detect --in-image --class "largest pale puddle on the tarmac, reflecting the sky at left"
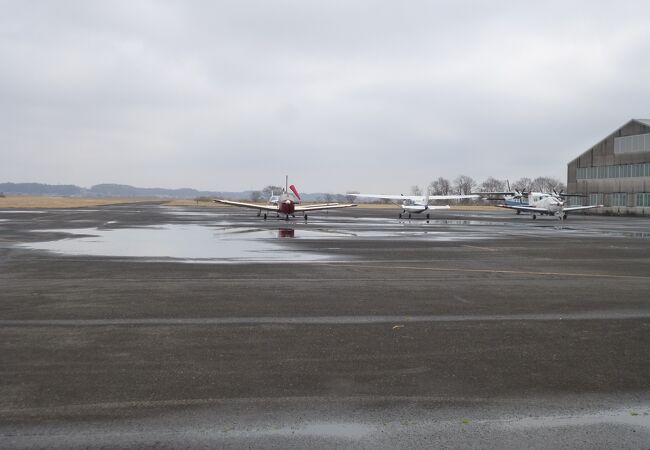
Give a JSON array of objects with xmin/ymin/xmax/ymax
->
[{"xmin": 18, "ymin": 225, "xmax": 330, "ymax": 263}]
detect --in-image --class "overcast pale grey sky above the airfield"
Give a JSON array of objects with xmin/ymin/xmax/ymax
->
[{"xmin": 0, "ymin": 0, "xmax": 650, "ymax": 192}]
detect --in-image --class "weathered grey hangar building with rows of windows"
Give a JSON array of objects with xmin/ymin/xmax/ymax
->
[{"xmin": 567, "ymin": 119, "xmax": 650, "ymax": 215}]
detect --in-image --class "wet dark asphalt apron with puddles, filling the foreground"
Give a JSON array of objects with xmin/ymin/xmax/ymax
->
[{"xmin": 0, "ymin": 204, "xmax": 650, "ymax": 449}]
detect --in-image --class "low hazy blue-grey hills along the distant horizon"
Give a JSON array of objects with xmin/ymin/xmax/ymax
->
[{"xmin": 0, "ymin": 183, "xmax": 334, "ymax": 201}]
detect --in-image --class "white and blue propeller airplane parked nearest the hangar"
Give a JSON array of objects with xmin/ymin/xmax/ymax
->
[{"xmin": 474, "ymin": 191, "xmax": 603, "ymax": 220}]
